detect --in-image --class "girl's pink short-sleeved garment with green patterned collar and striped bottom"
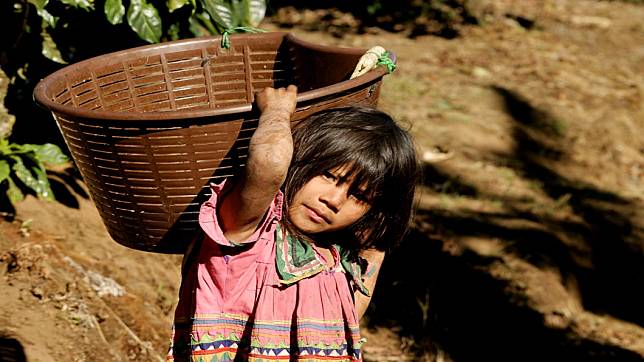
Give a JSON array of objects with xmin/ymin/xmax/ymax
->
[{"xmin": 168, "ymin": 181, "xmax": 363, "ymax": 361}]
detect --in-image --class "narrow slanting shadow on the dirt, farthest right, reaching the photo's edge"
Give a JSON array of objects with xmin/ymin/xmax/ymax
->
[{"xmin": 495, "ymin": 87, "xmax": 644, "ymax": 325}]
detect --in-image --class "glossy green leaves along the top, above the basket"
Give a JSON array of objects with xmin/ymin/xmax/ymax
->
[{"xmin": 8, "ymin": 0, "xmax": 266, "ymax": 64}]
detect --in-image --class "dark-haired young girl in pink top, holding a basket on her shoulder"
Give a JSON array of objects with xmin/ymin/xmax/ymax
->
[{"xmin": 168, "ymin": 86, "xmax": 418, "ymax": 362}]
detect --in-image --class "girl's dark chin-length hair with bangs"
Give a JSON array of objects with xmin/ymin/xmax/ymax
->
[{"xmin": 284, "ymin": 106, "xmax": 420, "ymax": 250}]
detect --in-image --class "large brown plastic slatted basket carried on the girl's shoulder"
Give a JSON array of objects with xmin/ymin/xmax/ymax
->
[{"xmin": 34, "ymin": 33, "xmax": 394, "ymax": 253}]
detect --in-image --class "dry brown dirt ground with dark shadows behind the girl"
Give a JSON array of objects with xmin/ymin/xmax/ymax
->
[{"xmin": 0, "ymin": 0, "xmax": 644, "ymax": 362}]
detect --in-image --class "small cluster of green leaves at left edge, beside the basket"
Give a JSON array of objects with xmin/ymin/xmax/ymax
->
[{"xmin": 0, "ymin": 138, "xmax": 68, "ymax": 203}]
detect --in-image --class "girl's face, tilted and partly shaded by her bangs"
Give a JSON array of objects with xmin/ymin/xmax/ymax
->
[{"xmin": 288, "ymin": 166, "xmax": 371, "ymax": 234}]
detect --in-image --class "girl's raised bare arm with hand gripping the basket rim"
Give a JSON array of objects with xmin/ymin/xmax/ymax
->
[{"xmin": 218, "ymin": 85, "xmax": 297, "ymax": 242}]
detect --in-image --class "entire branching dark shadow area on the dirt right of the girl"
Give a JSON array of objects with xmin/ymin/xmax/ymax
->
[{"xmin": 367, "ymin": 88, "xmax": 644, "ymax": 361}]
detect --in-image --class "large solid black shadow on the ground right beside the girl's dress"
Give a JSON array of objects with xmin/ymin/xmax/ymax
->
[{"xmin": 368, "ymin": 226, "xmax": 641, "ymax": 362}]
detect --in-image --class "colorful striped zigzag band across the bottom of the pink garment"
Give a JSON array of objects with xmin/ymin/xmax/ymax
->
[{"xmin": 168, "ymin": 313, "xmax": 364, "ymax": 361}]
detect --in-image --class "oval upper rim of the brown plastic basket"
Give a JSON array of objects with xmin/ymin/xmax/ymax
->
[{"xmin": 33, "ymin": 32, "xmax": 396, "ymax": 121}]
